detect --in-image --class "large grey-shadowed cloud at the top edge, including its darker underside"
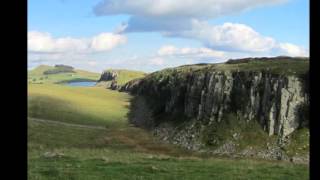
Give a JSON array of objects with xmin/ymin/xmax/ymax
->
[{"xmin": 93, "ymin": 0, "xmax": 287, "ymax": 32}]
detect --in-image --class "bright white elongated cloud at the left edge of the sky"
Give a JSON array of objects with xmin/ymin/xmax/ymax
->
[{"xmin": 28, "ymin": 31, "xmax": 127, "ymax": 53}]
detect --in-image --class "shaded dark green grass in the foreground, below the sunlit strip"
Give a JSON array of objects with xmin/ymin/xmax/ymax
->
[{"xmin": 28, "ymin": 121, "xmax": 308, "ymax": 180}]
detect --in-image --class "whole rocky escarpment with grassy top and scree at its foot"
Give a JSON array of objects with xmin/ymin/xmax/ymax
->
[{"xmin": 120, "ymin": 57, "xmax": 309, "ymax": 162}]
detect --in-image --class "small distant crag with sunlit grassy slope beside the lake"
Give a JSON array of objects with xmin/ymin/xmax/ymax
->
[{"xmin": 97, "ymin": 69, "xmax": 146, "ymax": 89}]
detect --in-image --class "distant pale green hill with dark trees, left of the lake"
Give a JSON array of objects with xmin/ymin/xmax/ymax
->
[{"xmin": 28, "ymin": 65, "xmax": 99, "ymax": 84}]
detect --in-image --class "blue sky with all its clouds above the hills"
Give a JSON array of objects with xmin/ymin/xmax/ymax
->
[{"xmin": 28, "ymin": 0, "xmax": 309, "ymax": 72}]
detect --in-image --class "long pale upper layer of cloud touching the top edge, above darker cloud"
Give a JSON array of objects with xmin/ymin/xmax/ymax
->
[{"xmin": 94, "ymin": 0, "xmax": 286, "ymax": 18}]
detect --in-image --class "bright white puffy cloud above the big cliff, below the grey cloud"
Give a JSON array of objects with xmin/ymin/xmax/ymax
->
[{"xmin": 165, "ymin": 20, "xmax": 276, "ymax": 52}]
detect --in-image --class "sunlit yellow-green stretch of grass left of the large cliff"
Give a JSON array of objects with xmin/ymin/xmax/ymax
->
[{"xmin": 28, "ymin": 84, "xmax": 130, "ymax": 126}]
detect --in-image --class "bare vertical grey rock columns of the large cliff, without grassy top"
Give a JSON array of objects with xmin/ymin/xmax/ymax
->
[{"xmin": 124, "ymin": 72, "xmax": 308, "ymax": 137}]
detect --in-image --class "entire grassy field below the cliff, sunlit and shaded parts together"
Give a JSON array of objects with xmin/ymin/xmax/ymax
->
[{"xmin": 28, "ymin": 68, "xmax": 309, "ymax": 180}]
